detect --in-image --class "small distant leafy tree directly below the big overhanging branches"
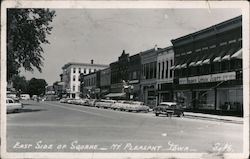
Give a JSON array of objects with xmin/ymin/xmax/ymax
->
[{"xmin": 12, "ymin": 75, "xmax": 28, "ymax": 93}]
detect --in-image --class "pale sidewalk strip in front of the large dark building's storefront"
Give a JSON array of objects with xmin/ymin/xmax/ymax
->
[{"xmin": 184, "ymin": 112, "xmax": 243, "ymax": 124}]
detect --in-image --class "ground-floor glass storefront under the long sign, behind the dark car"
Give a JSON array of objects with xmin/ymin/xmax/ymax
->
[{"xmin": 174, "ymin": 75, "xmax": 243, "ymax": 116}]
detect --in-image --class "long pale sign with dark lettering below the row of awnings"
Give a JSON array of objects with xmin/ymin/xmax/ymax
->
[{"xmin": 179, "ymin": 72, "xmax": 236, "ymax": 84}]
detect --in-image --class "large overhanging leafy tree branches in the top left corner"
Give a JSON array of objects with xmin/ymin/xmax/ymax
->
[{"xmin": 7, "ymin": 9, "xmax": 55, "ymax": 80}]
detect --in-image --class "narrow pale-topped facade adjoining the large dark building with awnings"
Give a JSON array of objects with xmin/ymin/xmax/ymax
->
[{"xmin": 156, "ymin": 46, "xmax": 174, "ymax": 103}]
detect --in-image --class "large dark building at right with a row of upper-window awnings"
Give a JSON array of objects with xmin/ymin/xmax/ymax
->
[{"xmin": 172, "ymin": 16, "xmax": 243, "ymax": 115}]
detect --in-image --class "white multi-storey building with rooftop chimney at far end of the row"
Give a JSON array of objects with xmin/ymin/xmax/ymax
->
[{"xmin": 62, "ymin": 60, "xmax": 109, "ymax": 99}]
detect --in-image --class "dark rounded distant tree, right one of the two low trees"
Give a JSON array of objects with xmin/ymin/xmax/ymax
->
[{"xmin": 28, "ymin": 78, "xmax": 47, "ymax": 97}]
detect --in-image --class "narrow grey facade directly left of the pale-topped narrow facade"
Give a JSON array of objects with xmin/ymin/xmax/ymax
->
[{"xmin": 140, "ymin": 46, "xmax": 159, "ymax": 107}]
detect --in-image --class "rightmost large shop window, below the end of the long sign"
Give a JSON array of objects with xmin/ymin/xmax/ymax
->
[{"xmin": 217, "ymin": 88, "xmax": 243, "ymax": 112}]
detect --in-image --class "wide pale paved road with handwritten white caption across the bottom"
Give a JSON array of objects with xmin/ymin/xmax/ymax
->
[{"xmin": 7, "ymin": 101, "xmax": 243, "ymax": 152}]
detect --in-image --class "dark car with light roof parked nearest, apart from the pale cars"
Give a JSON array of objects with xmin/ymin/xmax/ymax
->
[{"xmin": 153, "ymin": 102, "xmax": 184, "ymax": 117}]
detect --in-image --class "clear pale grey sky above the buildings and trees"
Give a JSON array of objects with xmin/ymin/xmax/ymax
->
[{"xmin": 21, "ymin": 8, "xmax": 241, "ymax": 85}]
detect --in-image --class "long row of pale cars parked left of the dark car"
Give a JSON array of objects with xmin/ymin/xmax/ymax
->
[{"xmin": 60, "ymin": 99, "xmax": 149, "ymax": 112}]
